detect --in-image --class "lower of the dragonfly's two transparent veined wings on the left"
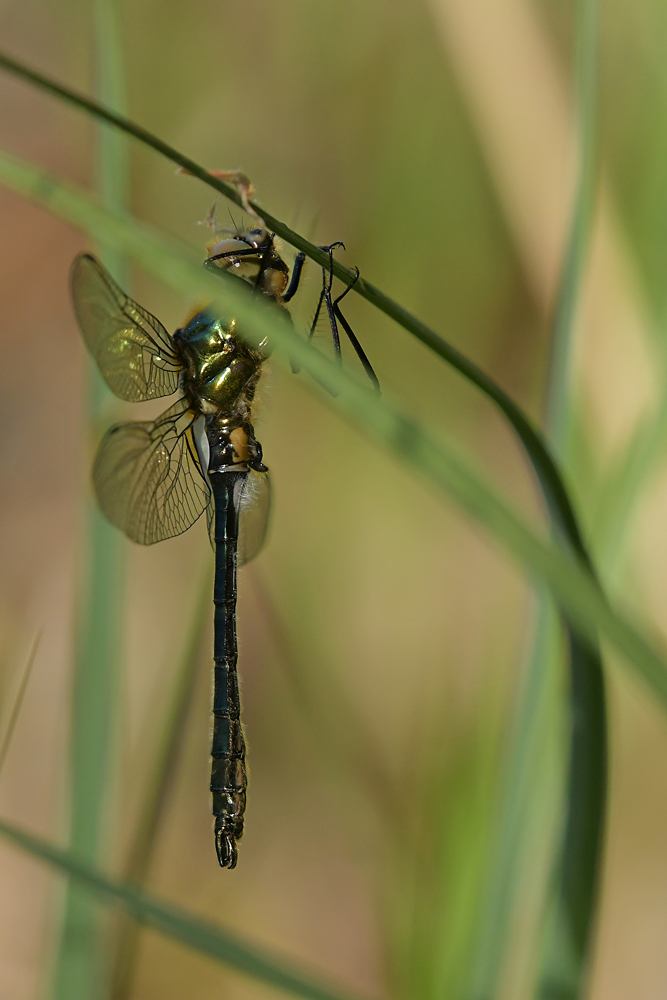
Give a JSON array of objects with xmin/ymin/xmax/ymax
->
[{"xmin": 93, "ymin": 399, "xmax": 210, "ymax": 545}]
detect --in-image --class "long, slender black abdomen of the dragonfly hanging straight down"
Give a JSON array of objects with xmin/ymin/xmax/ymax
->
[{"xmin": 209, "ymin": 471, "xmax": 248, "ymax": 868}]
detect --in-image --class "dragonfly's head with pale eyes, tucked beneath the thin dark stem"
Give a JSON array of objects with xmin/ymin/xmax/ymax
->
[{"xmin": 206, "ymin": 229, "xmax": 289, "ymax": 299}]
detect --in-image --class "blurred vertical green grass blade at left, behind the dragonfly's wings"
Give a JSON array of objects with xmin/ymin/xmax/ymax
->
[{"xmin": 52, "ymin": 0, "xmax": 128, "ymax": 1000}]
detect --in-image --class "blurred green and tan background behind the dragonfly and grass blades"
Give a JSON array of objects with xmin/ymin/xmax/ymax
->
[{"xmin": 0, "ymin": 0, "xmax": 667, "ymax": 1000}]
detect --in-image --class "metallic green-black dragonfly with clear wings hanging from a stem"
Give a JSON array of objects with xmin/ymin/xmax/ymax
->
[{"xmin": 70, "ymin": 226, "xmax": 378, "ymax": 869}]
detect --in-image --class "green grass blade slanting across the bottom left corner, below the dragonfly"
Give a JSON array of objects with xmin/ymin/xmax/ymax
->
[{"xmin": 0, "ymin": 821, "xmax": 366, "ymax": 1000}]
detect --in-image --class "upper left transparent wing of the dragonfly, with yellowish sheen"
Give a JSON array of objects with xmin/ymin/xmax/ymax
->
[{"xmin": 70, "ymin": 253, "xmax": 181, "ymax": 403}]
